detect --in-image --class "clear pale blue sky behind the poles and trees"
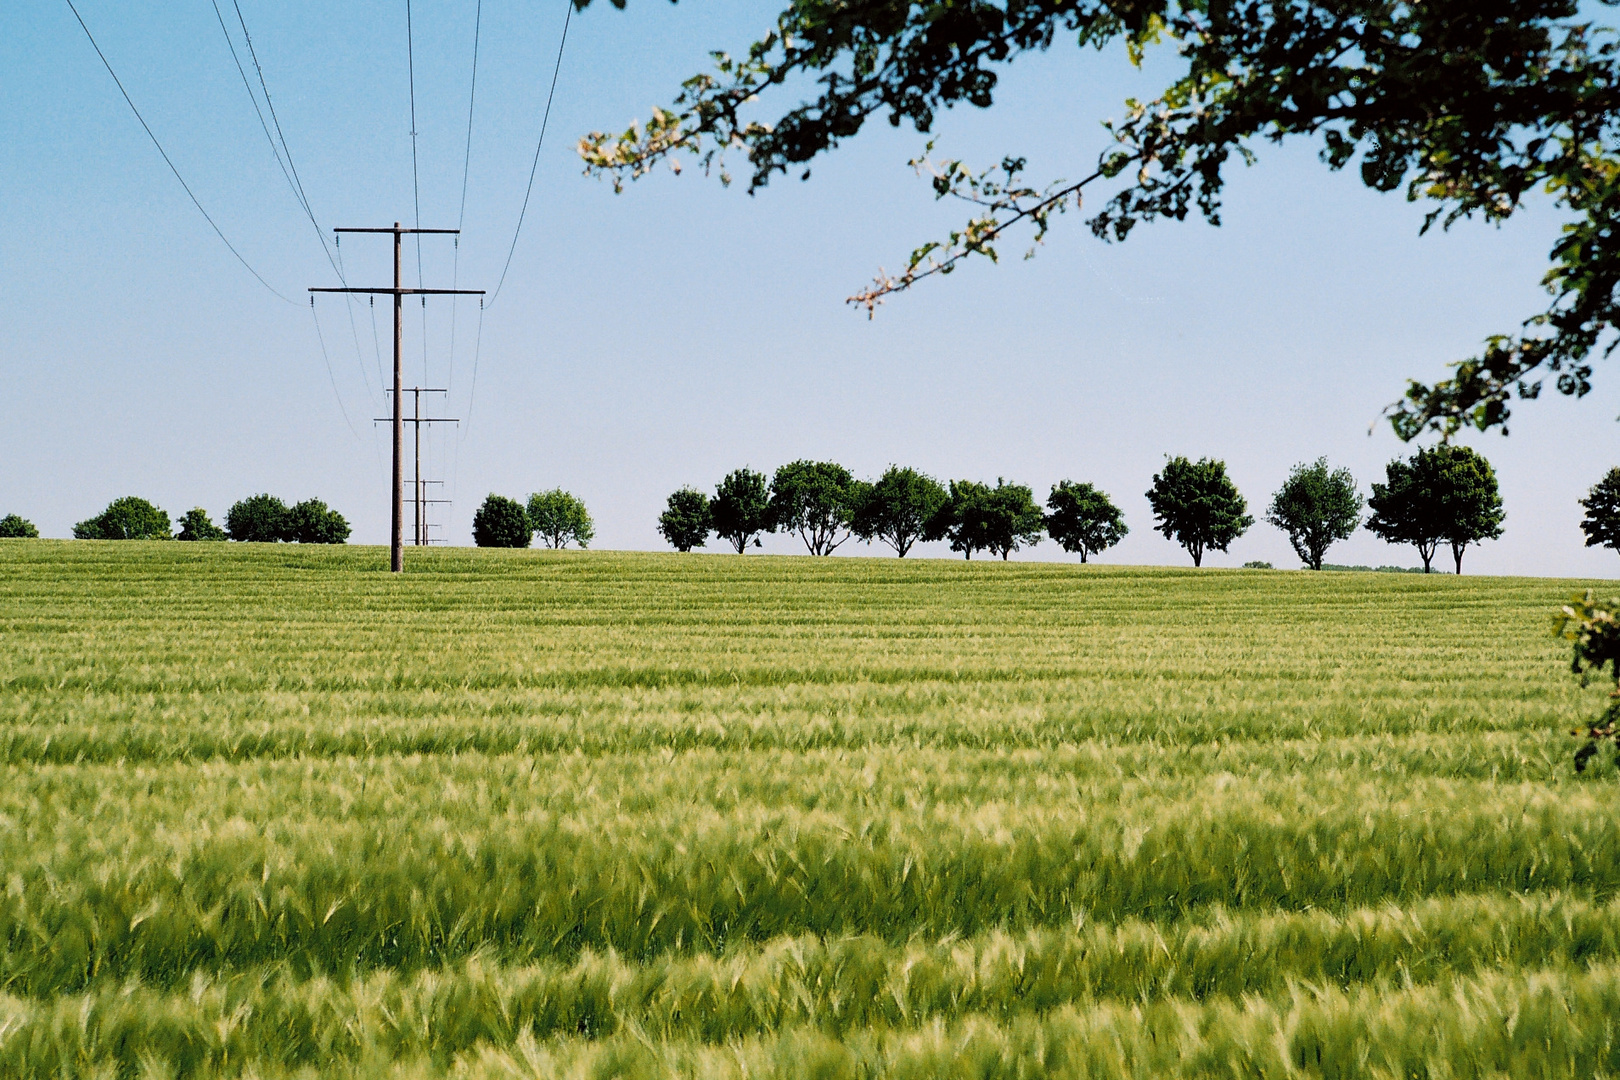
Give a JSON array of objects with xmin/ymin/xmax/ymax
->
[{"xmin": 0, "ymin": 0, "xmax": 1620, "ymax": 578}]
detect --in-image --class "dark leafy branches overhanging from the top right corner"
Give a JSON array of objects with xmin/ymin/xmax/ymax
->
[{"xmin": 577, "ymin": 0, "xmax": 1620, "ymax": 439}]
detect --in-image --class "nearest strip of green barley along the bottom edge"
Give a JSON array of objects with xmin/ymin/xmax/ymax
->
[{"xmin": 9, "ymin": 938, "xmax": 1620, "ymax": 1080}]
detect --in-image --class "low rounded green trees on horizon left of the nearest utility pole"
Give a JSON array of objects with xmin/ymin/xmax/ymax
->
[{"xmin": 51, "ymin": 495, "xmax": 348, "ymax": 544}]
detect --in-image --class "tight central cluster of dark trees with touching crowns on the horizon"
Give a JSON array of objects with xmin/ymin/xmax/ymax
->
[{"xmin": 658, "ymin": 460, "xmax": 1129, "ymax": 562}]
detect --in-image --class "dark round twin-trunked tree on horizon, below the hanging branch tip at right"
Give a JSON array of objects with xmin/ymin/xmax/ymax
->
[{"xmin": 1367, "ymin": 444, "xmax": 1505, "ymax": 573}]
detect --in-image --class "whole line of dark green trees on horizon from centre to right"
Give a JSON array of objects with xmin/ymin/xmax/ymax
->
[{"xmin": 658, "ymin": 444, "xmax": 1516, "ymax": 573}]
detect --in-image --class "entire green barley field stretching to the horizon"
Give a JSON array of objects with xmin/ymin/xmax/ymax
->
[{"xmin": 0, "ymin": 541, "xmax": 1620, "ymax": 1080}]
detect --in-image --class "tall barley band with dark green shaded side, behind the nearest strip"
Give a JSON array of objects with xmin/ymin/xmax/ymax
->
[{"xmin": 9, "ymin": 777, "xmax": 1620, "ymax": 994}]
